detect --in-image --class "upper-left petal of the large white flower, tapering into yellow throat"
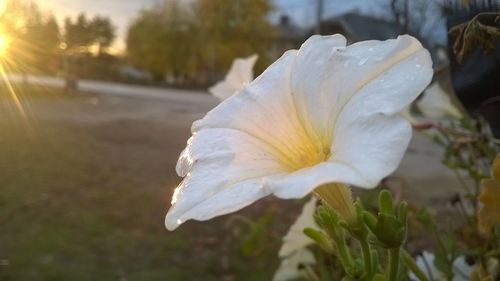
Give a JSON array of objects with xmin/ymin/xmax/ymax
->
[{"xmin": 192, "ymin": 50, "xmax": 315, "ymax": 171}]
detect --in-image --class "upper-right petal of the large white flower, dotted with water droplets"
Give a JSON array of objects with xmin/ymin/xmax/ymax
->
[{"xmin": 292, "ymin": 35, "xmax": 433, "ymax": 143}]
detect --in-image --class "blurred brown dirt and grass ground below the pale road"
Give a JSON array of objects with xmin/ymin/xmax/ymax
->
[{"xmin": 0, "ymin": 84, "xmax": 462, "ymax": 280}]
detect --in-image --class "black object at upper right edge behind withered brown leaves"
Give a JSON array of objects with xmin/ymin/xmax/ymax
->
[{"xmin": 448, "ymin": 7, "xmax": 500, "ymax": 137}]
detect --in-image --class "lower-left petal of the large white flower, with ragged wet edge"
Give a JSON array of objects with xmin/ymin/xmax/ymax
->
[{"xmin": 165, "ymin": 129, "xmax": 282, "ymax": 230}]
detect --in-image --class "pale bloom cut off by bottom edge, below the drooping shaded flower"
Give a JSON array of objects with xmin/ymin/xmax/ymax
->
[{"xmin": 273, "ymin": 249, "xmax": 316, "ymax": 281}]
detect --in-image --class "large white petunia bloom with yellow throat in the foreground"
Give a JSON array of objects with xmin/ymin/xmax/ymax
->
[{"xmin": 165, "ymin": 34, "xmax": 433, "ymax": 230}]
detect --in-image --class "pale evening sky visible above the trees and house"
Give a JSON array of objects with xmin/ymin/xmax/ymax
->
[{"xmin": 32, "ymin": 0, "xmax": 446, "ymax": 52}]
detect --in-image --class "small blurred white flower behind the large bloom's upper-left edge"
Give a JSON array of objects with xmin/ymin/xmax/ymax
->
[{"xmin": 208, "ymin": 55, "xmax": 258, "ymax": 100}]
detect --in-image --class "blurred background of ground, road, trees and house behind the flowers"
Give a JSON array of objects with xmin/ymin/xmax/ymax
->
[{"xmin": 0, "ymin": 0, "xmax": 500, "ymax": 281}]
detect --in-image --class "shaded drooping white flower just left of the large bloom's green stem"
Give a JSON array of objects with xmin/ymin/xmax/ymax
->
[{"xmin": 279, "ymin": 197, "xmax": 319, "ymax": 258}]
